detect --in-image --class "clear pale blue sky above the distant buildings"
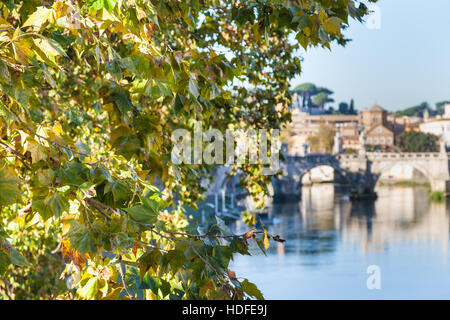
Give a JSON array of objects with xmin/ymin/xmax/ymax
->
[{"xmin": 292, "ymin": 0, "xmax": 450, "ymax": 111}]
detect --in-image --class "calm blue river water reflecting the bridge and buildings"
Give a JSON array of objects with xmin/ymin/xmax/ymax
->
[{"xmin": 230, "ymin": 184, "xmax": 450, "ymax": 299}]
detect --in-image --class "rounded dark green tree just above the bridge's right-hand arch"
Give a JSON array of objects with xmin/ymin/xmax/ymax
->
[{"xmin": 397, "ymin": 131, "xmax": 439, "ymax": 152}]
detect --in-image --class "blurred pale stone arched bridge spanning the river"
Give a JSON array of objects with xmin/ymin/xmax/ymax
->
[{"xmin": 272, "ymin": 152, "xmax": 450, "ymax": 201}]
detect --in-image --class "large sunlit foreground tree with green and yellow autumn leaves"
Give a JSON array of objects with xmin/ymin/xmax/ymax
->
[{"xmin": 0, "ymin": 0, "xmax": 374, "ymax": 299}]
